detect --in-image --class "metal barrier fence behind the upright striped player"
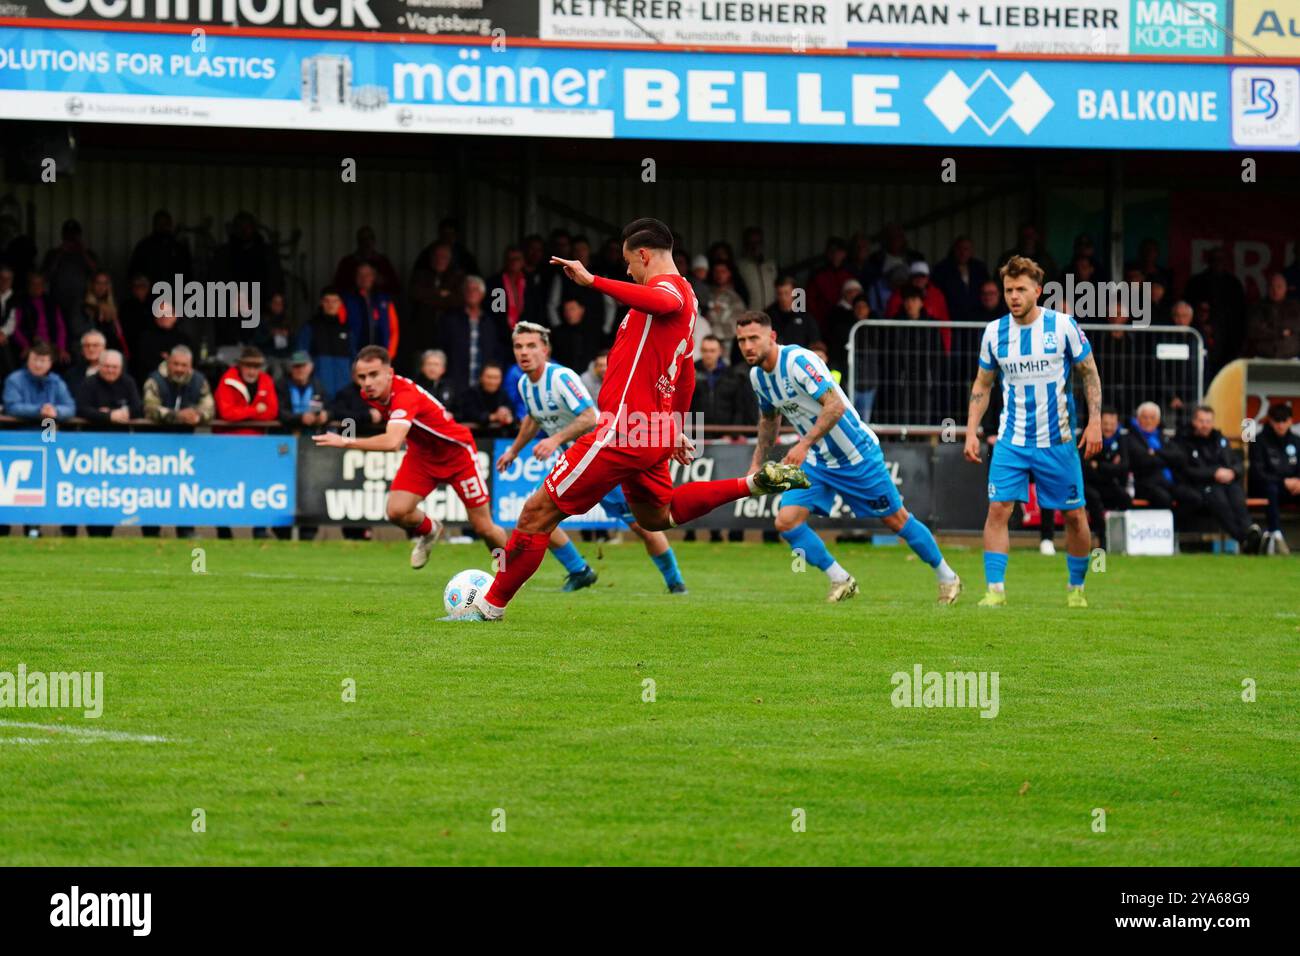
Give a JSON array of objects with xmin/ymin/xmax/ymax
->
[{"xmin": 845, "ymin": 319, "xmax": 1205, "ymax": 433}]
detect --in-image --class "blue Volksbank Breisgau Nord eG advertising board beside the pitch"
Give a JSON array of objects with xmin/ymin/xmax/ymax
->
[{"xmin": 0, "ymin": 432, "xmax": 296, "ymax": 527}]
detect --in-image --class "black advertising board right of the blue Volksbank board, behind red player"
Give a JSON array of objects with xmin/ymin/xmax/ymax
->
[{"xmin": 298, "ymin": 437, "xmax": 491, "ymax": 524}]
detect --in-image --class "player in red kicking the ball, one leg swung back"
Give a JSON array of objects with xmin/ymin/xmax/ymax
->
[{"xmin": 443, "ymin": 219, "xmax": 809, "ymax": 622}]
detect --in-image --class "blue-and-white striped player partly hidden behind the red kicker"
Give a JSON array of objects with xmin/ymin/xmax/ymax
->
[{"xmin": 497, "ymin": 323, "xmax": 686, "ymax": 594}]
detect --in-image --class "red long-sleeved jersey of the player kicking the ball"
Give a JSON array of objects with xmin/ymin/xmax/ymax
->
[{"xmin": 594, "ymin": 274, "xmax": 699, "ymax": 415}]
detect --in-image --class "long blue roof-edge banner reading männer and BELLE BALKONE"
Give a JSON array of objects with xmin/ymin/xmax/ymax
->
[{"xmin": 0, "ymin": 29, "xmax": 1279, "ymax": 150}]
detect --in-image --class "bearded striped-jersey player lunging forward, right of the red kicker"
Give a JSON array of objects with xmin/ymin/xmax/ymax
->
[{"xmin": 736, "ymin": 312, "xmax": 962, "ymax": 605}]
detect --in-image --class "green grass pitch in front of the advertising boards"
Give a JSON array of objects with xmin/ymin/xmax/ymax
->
[{"xmin": 0, "ymin": 538, "xmax": 1300, "ymax": 865}]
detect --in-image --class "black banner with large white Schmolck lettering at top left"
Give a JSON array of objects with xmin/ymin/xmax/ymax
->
[{"xmin": 0, "ymin": 0, "xmax": 538, "ymax": 36}]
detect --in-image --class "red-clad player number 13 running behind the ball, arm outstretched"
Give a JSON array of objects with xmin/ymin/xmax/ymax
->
[{"xmin": 312, "ymin": 345, "xmax": 506, "ymax": 568}]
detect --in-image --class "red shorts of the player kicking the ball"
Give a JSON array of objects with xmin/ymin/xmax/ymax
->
[{"xmin": 545, "ymin": 432, "xmax": 672, "ymax": 515}]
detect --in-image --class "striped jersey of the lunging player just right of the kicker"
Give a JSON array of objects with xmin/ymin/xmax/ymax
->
[{"xmin": 749, "ymin": 345, "xmax": 880, "ymax": 468}]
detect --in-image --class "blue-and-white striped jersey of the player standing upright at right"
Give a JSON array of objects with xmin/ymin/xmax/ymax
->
[{"xmin": 979, "ymin": 308, "xmax": 1092, "ymax": 449}]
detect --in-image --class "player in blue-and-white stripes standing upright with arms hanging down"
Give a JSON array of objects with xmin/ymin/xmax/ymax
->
[{"xmin": 966, "ymin": 256, "xmax": 1101, "ymax": 607}]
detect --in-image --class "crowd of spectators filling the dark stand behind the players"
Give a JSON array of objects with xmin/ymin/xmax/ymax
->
[{"xmin": 0, "ymin": 211, "xmax": 1300, "ymax": 545}]
